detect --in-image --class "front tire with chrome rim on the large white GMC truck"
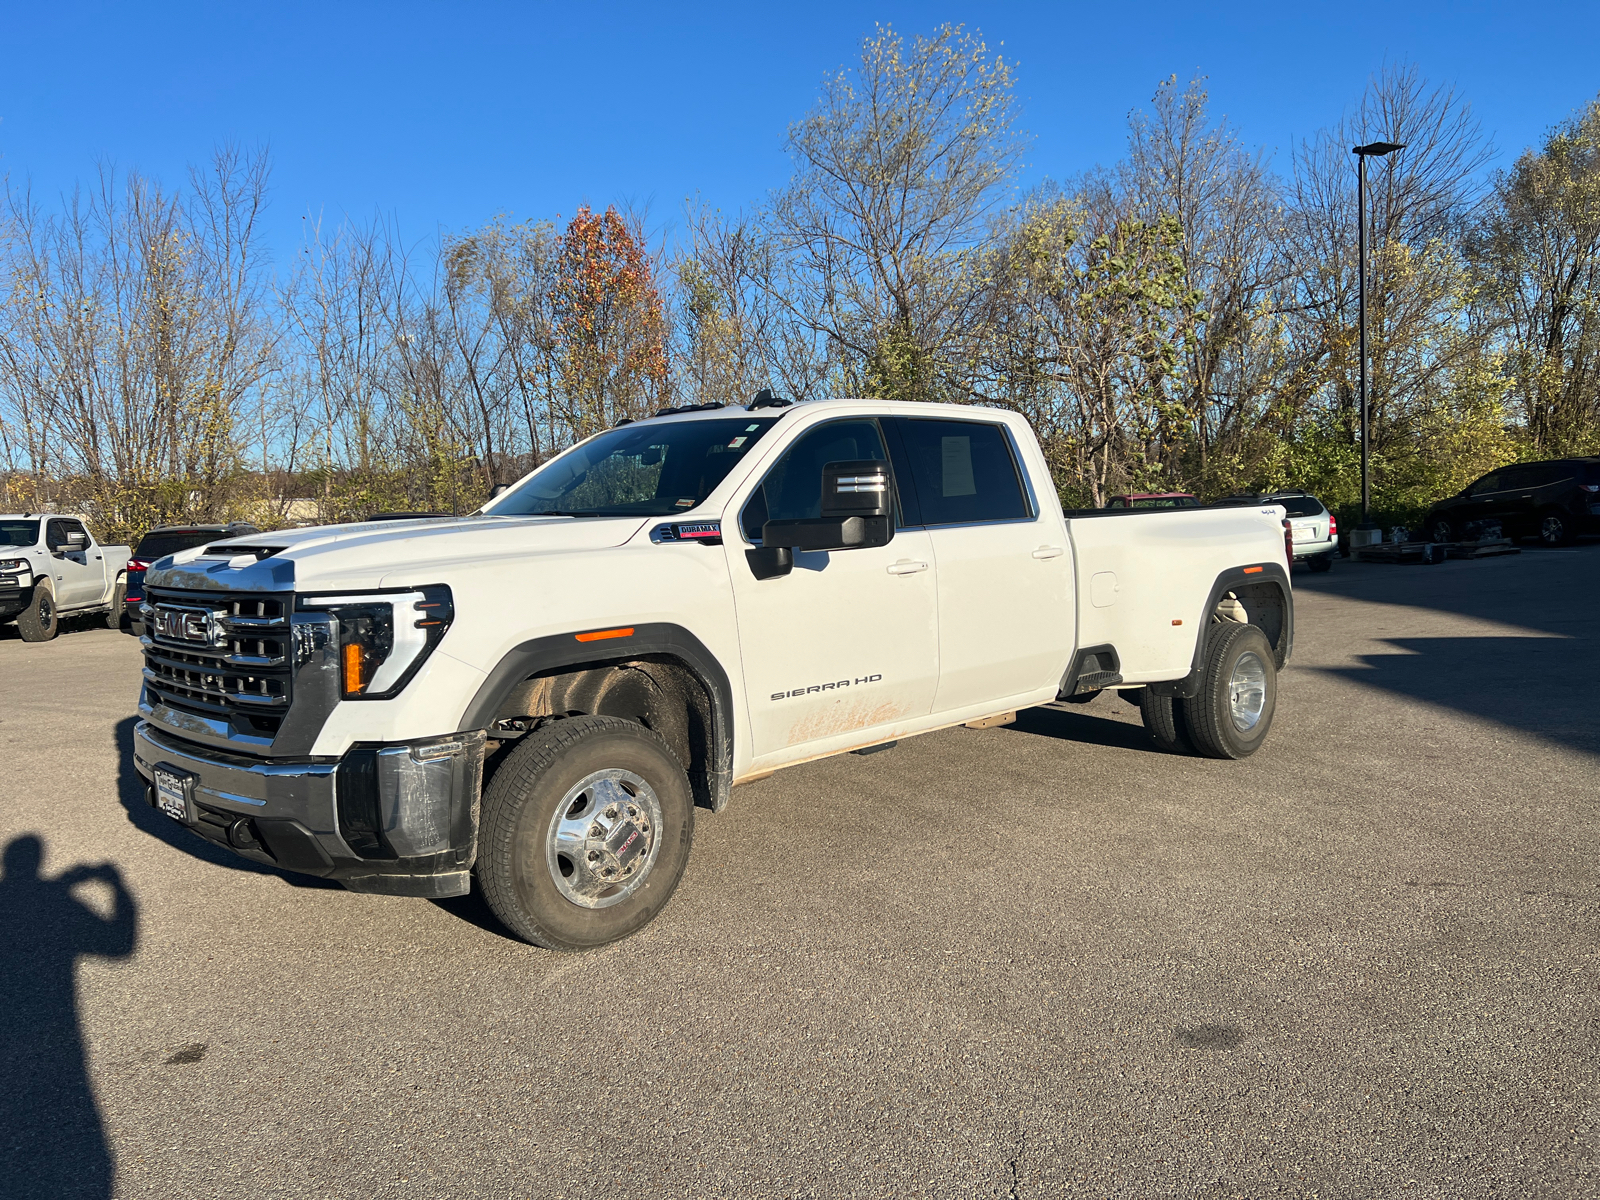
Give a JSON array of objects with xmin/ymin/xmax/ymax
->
[{"xmin": 477, "ymin": 717, "xmax": 694, "ymax": 950}]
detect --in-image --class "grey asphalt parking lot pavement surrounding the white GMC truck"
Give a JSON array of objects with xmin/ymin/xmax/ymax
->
[{"xmin": 0, "ymin": 544, "xmax": 1600, "ymax": 1198}]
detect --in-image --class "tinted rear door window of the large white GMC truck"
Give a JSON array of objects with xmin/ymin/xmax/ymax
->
[{"xmin": 896, "ymin": 418, "xmax": 1034, "ymax": 525}]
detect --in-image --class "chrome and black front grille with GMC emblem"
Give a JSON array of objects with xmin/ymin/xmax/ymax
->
[{"xmin": 144, "ymin": 587, "xmax": 294, "ymax": 734}]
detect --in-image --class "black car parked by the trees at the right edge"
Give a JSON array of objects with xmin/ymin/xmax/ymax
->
[{"xmin": 1422, "ymin": 458, "xmax": 1600, "ymax": 546}]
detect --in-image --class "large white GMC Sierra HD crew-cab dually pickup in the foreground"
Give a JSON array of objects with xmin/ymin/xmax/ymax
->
[{"xmin": 134, "ymin": 398, "xmax": 1294, "ymax": 950}]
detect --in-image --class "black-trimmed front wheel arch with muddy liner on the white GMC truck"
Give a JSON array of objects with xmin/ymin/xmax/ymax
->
[{"xmin": 458, "ymin": 624, "xmax": 734, "ymax": 813}]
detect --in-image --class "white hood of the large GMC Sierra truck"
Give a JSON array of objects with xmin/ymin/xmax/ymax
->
[{"xmin": 147, "ymin": 517, "xmax": 646, "ymax": 592}]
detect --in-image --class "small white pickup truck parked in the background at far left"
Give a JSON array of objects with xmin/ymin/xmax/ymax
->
[{"xmin": 0, "ymin": 512, "xmax": 130, "ymax": 642}]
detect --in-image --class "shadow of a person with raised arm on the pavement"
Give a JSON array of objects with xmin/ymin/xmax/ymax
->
[{"xmin": 0, "ymin": 834, "xmax": 139, "ymax": 1200}]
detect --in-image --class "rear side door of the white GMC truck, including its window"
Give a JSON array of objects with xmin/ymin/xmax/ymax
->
[{"xmin": 886, "ymin": 418, "xmax": 1075, "ymax": 712}]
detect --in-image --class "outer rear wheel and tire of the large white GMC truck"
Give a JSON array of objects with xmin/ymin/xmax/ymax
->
[{"xmin": 1184, "ymin": 622, "xmax": 1278, "ymax": 758}]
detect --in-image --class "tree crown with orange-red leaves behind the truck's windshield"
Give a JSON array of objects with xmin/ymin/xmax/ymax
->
[{"xmin": 552, "ymin": 205, "xmax": 667, "ymax": 438}]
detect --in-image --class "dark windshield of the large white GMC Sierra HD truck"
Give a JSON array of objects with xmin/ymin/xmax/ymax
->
[{"xmin": 485, "ymin": 416, "xmax": 778, "ymax": 517}]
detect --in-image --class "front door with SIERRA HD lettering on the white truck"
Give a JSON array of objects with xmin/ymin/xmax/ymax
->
[{"xmin": 723, "ymin": 418, "xmax": 939, "ymax": 766}]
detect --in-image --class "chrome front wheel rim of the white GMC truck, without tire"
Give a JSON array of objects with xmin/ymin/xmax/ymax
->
[{"xmin": 546, "ymin": 770, "xmax": 661, "ymax": 909}]
